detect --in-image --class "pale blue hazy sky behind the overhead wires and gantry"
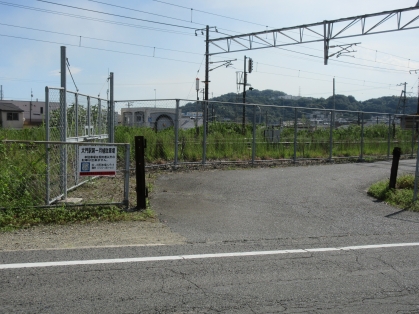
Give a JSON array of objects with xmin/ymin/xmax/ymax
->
[{"xmin": 0, "ymin": 0, "xmax": 419, "ymax": 101}]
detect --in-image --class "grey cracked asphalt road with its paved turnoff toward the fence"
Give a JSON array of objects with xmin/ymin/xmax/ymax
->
[{"xmin": 0, "ymin": 160, "xmax": 419, "ymax": 313}]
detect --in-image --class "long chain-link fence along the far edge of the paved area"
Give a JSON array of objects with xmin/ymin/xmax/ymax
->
[{"xmin": 115, "ymin": 100, "xmax": 417, "ymax": 166}]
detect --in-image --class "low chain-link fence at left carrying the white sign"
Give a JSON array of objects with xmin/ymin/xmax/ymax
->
[{"xmin": 0, "ymin": 141, "xmax": 133, "ymax": 208}]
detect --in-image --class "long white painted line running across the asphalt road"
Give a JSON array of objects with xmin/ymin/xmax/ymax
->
[{"xmin": 0, "ymin": 242, "xmax": 419, "ymax": 269}]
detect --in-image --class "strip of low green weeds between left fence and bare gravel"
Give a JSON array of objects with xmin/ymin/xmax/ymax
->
[{"xmin": 0, "ymin": 206, "xmax": 154, "ymax": 231}]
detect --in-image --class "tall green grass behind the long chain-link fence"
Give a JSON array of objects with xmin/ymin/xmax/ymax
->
[{"xmin": 110, "ymin": 122, "xmax": 417, "ymax": 164}]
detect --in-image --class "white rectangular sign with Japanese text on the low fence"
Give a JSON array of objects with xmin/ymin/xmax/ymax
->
[{"xmin": 78, "ymin": 145, "xmax": 117, "ymax": 176}]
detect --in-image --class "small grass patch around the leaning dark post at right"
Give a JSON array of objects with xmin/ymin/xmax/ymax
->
[{"xmin": 368, "ymin": 174, "xmax": 419, "ymax": 211}]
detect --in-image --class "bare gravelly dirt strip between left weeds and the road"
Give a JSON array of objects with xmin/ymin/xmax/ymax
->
[{"xmin": 0, "ymin": 221, "xmax": 185, "ymax": 251}]
